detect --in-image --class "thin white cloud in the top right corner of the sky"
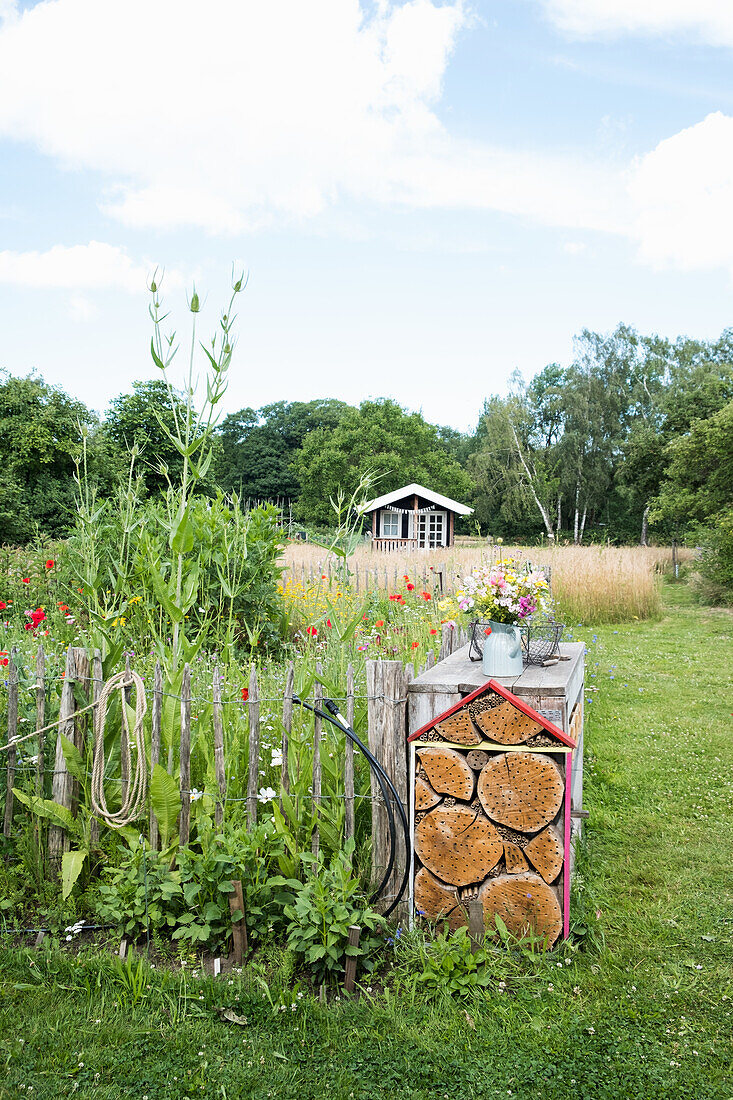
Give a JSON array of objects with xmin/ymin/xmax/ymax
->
[{"xmin": 540, "ymin": 0, "xmax": 733, "ymax": 46}]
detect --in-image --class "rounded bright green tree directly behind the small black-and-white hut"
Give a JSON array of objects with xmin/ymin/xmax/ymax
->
[{"xmin": 294, "ymin": 398, "xmax": 473, "ymax": 527}]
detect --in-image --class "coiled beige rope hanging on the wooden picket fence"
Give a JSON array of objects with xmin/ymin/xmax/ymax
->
[{"xmin": 91, "ymin": 670, "xmax": 147, "ymax": 828}]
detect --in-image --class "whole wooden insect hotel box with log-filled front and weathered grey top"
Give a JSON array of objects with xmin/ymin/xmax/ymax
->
[{"xmin": 408, "ymin": 645, "xmax": 584, "ymax": 945}]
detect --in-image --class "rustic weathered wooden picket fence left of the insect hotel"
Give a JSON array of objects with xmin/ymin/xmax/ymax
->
[{"xmin": 0, "ymin": 624, "xmax": 468, "ymax": 898}]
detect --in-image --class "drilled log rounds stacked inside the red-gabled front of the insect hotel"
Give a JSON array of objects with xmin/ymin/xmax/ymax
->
[{"xmin": 414, "ymin": 689, "xmax": 568, "ymax": 944}]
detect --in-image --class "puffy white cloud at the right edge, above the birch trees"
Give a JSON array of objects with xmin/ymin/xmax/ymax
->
[{"xmin": 628, "ymin": 111, "xmax": 733, "ymax": 273}]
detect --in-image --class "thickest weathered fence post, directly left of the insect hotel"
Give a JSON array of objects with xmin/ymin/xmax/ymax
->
[{"xmin": 367, "ymin": 661, "xmax": 407, "ymax": 899}]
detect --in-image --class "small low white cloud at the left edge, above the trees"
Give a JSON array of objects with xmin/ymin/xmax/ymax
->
[{"xmin": 0, "ymin": 241, "xmax": 154, "ymax": 294}]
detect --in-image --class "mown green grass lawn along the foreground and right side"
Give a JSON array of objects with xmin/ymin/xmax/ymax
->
[{"xmin": 0, "ymin": 586, "xmax": 733, "ymax": 1100}]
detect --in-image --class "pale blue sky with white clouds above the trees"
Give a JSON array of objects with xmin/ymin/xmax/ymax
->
[{"xmin": 0, "ymin": 0, "xmax": 733, "ymax": 431}]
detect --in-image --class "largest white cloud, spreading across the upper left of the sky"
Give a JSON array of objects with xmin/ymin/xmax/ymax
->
[{"xmin": 0, "ymin": 0, "xmax": 623, "ymax": 233}]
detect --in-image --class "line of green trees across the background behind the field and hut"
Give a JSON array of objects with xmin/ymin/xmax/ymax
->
[{"xmin": 0, "ymin": 325, "xmax": 733, "ymax": 558}]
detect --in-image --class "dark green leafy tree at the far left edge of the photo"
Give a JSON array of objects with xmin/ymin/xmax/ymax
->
[{"xmin": 0, "ymin": 374, "xmax": 101, "ymax": 543}]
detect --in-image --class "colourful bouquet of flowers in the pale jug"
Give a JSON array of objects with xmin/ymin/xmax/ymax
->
[{"xmin": 456, "ymin": 559, "xmax": 550, "ymax": 626}]
